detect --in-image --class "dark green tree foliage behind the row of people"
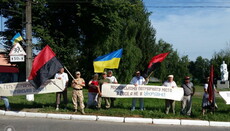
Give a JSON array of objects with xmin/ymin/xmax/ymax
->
[{"xmin": 0, "ymin": 0, "xmax": 221, "ymax": 84}]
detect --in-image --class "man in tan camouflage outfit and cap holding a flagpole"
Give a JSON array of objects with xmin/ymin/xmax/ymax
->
[{"xmin": 72, "ymin": 71, "xmax": 85, "ymax": 114}]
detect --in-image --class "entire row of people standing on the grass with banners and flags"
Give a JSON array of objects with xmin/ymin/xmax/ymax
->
[{"xmin": 1, "ymin": 68, "xmax": 218, "ymax": 116}]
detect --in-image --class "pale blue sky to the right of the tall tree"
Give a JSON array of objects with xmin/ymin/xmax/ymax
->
[{"xmin": 143, "ymin": 0, "xmax": 230, "ymax": 61}]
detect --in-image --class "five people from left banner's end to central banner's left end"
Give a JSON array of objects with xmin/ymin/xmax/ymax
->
[{"xmin": 55, "ymin": 68, "xmax": 118, "ymax": 114}]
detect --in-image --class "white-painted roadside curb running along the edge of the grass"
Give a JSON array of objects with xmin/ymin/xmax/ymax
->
[{"xmin": 0, "ymin": 110, "xmax": 230, "ymax": 127}]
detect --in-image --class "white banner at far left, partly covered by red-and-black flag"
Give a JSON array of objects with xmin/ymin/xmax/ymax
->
[{"xmin": 0, "ymin": 79, "xmax": 65, "ymax": 96}]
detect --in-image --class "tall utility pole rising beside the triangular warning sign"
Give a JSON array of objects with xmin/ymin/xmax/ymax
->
[{"xmin": 26, "ymin": 0, "xmax": 32, "ymax": 78}]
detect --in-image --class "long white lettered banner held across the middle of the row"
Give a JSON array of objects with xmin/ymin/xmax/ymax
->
[{"xmin": 102, "ymin": 84, "xmax": 184, "ymax": 101}]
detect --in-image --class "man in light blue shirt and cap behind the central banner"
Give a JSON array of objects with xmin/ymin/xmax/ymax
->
[{"xmin": 130, "ymin": 71, "xmax": 148, "ymax": 111}]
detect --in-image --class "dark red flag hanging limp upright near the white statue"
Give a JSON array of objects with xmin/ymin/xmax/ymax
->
[{"xmin": 208, "ymin": 65, "xmax": 214, "ymax": 103}]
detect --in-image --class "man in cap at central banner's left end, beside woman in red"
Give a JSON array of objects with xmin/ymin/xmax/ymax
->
[{"xmin": 97, "ymin": 72, "xmax": 110, "ymax": 109}]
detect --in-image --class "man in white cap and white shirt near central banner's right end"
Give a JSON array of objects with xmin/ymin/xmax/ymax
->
[{"xmin": 162, "ymin": 75, "xmax": 177, "ymax": 114}]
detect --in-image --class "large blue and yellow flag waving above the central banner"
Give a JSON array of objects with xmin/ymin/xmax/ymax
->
[{"xmin": 93, "ymin": 49, "xmax": 123, "ymax": 73}]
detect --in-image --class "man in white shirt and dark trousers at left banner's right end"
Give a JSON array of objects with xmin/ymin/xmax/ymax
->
[{"xmin": 54, "ymin": 68, "xmax": 69, "ymax": 110}]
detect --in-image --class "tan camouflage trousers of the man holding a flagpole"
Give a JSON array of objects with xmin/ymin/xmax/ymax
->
[{"xmin": 72, "ymin": 89, "xmax": 85, "ymax": 110}]
